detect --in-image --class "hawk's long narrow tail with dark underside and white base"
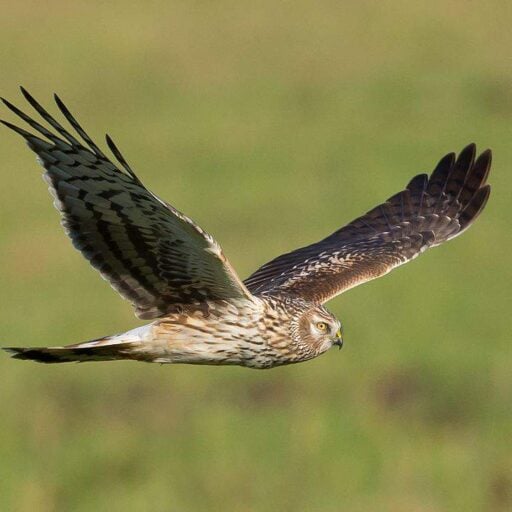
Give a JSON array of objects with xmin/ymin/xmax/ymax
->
[{"xmin": 3, "ymin": 326, "xmax": 147, "ymax": 364}]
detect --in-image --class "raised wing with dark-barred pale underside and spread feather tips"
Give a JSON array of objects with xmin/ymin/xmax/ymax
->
[{"xmin": 2, "ymin": 88, "xmax": 251, "ymax": 318}]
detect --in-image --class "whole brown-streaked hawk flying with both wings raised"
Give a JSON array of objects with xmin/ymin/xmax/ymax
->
[{"xmin": 2, "ymin": 88, "xmax": 491, "ymax": 368}]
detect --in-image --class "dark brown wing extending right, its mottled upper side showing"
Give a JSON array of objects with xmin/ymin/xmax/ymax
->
[{"xmin": 245, "ymin": 144, "xmax": 491, "ymax": 303}]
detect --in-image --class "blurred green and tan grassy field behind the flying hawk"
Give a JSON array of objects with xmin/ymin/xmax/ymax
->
[{"xmin": 0, "ymin": 0, "xmax": 512, "ymax": 512}]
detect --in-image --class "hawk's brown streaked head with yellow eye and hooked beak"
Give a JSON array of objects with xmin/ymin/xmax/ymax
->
[{"xmin": 299, "ymin": 306, "xmax": 343, "ymax": 354}]
